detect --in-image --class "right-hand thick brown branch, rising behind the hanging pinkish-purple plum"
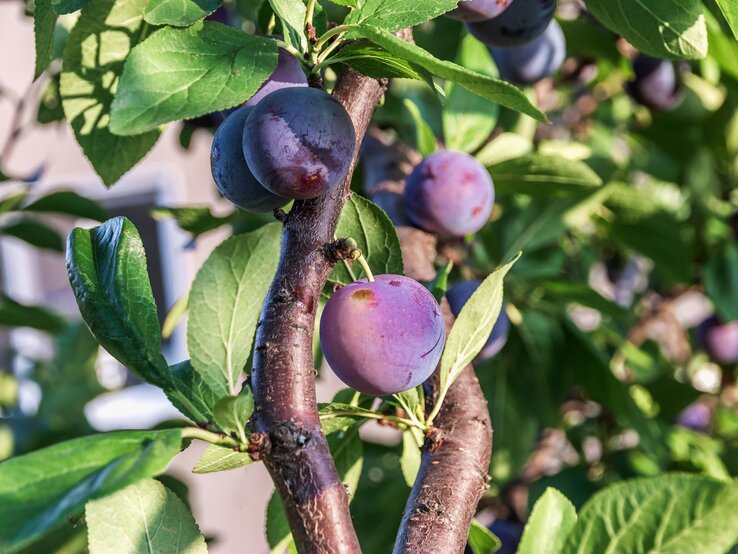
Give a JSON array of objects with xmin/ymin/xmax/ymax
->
[{"xmin": 363, "ymin": 134, "xmax": 492, "ymax": 554}]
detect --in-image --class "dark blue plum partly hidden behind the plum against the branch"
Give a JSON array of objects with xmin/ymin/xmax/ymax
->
[{"xmin": 210, "ymin": 106, "xmax": 289, "ymax": 212}]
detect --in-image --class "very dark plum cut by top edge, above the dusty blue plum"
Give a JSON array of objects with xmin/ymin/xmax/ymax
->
[{"xmin": 466, "ymin": 0, "xmax": 556, "ymax": 48}]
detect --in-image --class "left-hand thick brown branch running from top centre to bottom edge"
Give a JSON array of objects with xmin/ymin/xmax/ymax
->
[{"xmin": 251, "ymin": 69, "xmax": 384, "ymax": 553}]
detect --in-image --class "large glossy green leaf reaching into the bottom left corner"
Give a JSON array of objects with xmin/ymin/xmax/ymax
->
[{"xmin": 0, "ymin": 429, "xmax": 181, "ymax": 552}]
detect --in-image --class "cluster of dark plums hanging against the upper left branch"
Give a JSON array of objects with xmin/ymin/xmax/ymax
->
[{"xmin": 210, "ymin": 51, "xmax": 356, "ymax": 212}]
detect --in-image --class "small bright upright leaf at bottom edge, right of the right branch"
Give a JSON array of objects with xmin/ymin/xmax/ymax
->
[{"xmin": 518, "ymin": 488, "xmax": 577, "ymax": 554}]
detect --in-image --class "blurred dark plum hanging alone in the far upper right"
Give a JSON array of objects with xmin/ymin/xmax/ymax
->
[{"xmin": 627, "ymin": 54, "xmax": 682, "ymax": 110}]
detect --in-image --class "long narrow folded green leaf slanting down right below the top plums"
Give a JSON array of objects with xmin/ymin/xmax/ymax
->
[{"xmin": 348, "ymin": 25, "xmax": 546, "ymax": 121}]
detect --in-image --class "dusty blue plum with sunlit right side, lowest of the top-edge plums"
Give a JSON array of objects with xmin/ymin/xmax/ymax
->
[{"xmin": 489, "ymin": 20, "xmax": 566, "ymax": 85}]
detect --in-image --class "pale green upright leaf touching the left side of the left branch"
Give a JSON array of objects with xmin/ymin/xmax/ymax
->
[{"xmin": 187, "ymin": 223, "xmax": 281, "ymax": 396}]
